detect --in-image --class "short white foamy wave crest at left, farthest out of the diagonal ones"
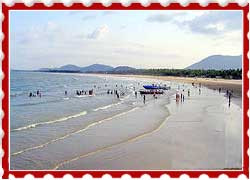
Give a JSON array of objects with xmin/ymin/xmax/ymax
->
[{"xmin": 11, "ymin": 111, "xmax": 87, "ymax": 132}]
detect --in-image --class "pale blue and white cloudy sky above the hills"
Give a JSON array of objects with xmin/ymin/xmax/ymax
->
[{"xmin": 10, "ymin": 10, "xmax": 243, "ymax": 70}]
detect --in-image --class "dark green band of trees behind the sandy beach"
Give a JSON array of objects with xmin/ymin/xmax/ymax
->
[{"xmin": 108, "ymin": 69, "xmax": 242, "ymax": 79}]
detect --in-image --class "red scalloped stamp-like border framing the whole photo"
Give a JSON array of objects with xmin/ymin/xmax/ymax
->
[{"xmin": 2, "ymin": 3, "xmax": 249, "ymax": 179}]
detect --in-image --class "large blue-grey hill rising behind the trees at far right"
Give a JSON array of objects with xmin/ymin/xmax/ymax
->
[{"xmin": 185, "ymin": 55, "xmax": 242, "ymax": 70}]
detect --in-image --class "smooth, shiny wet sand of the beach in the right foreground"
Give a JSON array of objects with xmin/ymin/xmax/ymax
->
[{"xmin": 61, "ymin": 88, "xmax": 242, "ymax": 170}]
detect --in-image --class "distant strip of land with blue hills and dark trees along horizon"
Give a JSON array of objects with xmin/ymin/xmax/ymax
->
[{"xmin": 31, "ymin": 55, "xmax": 242, "ymax": 79}]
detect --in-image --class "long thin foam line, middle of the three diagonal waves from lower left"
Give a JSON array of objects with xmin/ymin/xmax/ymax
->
[{"xmin": 11, "ymin": 107, "xmax": 139, "ymax": 156}]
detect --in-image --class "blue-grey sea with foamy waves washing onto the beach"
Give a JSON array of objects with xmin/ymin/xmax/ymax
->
[{"xmin": 10, "ymin": 71, "xmax": 178, "ymax": 170}]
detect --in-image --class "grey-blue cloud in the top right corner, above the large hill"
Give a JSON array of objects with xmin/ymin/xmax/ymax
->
[{"xmin": 175, "ymin": 11, "xmax": 242, "ymax": 35}]
